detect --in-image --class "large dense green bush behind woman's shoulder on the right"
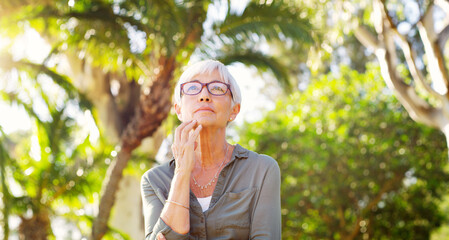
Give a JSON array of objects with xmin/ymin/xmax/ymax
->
[{"xmin": 239, "ymin": 66, "xmax": 449, "ymax": 239}]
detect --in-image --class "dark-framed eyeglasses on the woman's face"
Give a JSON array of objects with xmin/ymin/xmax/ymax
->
[{"xmin": 181, "ymin": 80, "xmax": 232, "ymax": 96}]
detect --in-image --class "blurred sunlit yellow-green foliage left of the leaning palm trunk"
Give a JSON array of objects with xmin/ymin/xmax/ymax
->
[{"xmin": 0, "ymin": 69, "xmax": 113, "ymax": 239}]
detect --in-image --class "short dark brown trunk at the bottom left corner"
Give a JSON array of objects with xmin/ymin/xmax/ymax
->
[{"xmin": 19, "ymin": 213, "xmax": 51, "ymax": 240}]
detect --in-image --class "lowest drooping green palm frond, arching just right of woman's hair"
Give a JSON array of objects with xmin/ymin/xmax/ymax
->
[{"xmin": 217, "ymin": 51, "xmax": 291, "ymax": 92}]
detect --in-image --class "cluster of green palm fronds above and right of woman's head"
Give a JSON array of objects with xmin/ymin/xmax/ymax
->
[{"xmin": 200, "ymin": 1, "xmax": 315, "ymax": 92}]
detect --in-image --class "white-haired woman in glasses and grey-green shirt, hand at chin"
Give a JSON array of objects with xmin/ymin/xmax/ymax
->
[{"xmin": 141, "ymin": 60, "xmax": 281, "ymax": 239}]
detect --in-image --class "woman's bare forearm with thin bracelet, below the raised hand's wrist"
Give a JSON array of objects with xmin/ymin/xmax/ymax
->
[{"xmin": 161, "ymin": 171, "xmax": 190, "ymax": 234}]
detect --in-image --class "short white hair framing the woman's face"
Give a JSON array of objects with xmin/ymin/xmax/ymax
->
[{"xmin": 174, "ymin": 60, "xmax": 242, "ymax": 106}]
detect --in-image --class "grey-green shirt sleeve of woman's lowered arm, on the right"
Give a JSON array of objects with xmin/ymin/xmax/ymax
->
[{"xmin": 250, "ymin": 158, "xmax": 281, "ymax": 240}]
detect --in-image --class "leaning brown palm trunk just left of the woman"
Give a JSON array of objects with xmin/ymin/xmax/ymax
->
[{"xmin": 91, "ymin": 58, "xmax": 175, "ymax": 240}]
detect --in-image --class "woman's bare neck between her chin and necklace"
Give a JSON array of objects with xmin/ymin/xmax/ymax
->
[{"xmin": 195, "ymin": 127, "xmax": 228, "ymax": 169}]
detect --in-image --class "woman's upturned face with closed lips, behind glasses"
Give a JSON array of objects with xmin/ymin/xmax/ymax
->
[{"xmin": 175, "ymin": 70, "xmax": 240, "ymax": 127}]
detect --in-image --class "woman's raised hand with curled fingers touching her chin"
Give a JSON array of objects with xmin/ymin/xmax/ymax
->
[{"xmin": 171, "ymin": 120, "xmax": 202, "ymax": 173}]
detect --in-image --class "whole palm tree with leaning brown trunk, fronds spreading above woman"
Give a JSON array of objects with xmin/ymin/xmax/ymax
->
[{"xmin": 0, "ymin": 0, "xmax": 312, "ymax": 239}]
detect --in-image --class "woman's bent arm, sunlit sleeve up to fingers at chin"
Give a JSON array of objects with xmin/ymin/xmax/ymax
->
[{"xmin": 142, "ymin": 121, "xmax": 202, "ymax": 239}]
